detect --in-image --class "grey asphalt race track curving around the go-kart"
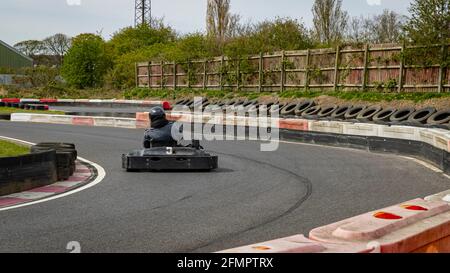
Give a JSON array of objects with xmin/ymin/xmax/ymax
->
[{"xmin": 0, "ymin": 122, "xmax": 450, "ymax": 252}]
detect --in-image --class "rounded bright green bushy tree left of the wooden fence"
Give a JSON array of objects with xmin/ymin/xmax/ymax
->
[{"xmin": 61, "ymin": 34, "xmax": 112, "ymax": 89}]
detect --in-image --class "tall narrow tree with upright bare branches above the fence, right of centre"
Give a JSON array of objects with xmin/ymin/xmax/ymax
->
[{"xmin": 312, "ymin": 0, "xmax": 348, "ymax": 45}]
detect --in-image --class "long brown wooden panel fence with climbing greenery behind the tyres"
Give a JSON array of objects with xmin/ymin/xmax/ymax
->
[{"xmin": 136, "ymin": 44, "xmax": 450, "ymax": 92}]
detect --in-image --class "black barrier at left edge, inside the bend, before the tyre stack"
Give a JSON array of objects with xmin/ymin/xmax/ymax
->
[{"xmin": 0, "ymin": 150, "xmax": 58, "ymax": 196}]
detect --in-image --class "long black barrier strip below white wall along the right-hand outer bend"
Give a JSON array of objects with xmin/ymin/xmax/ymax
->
[{"xmin": 280, "ymin": 129, "xmax": 450, "ymax": 174}]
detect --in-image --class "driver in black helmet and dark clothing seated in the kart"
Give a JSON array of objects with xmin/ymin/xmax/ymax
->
[{"xmin": 144, "ymin": 107, "xmax": 177, "ymax": 149}]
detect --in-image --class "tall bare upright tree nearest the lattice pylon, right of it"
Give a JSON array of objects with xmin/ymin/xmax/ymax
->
[{"xmin": 206, "ymin": 0, "xmax": 240, "ymax": 45}]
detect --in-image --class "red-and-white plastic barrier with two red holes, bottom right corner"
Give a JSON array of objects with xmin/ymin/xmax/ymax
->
[{"xmin": 309, "ymin": 199, "xmax": 450, "ymax": 253}]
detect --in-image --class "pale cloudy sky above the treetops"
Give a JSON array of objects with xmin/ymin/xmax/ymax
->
[{"xmin": 0, "ymin": 0, "xmax": 412, "ymax": 45}]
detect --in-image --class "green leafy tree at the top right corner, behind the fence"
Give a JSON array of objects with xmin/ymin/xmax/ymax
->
[{"xmin": 405, "ymin": 0, "xmax": 450, "ymax": 45}]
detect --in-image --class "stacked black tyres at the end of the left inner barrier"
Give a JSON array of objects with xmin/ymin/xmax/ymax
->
[{"xmin": 31, "ymin": 142, "xmax": 78, "ymax": 181}]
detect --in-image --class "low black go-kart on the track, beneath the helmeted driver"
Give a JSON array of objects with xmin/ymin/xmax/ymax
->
[{"xmin": 122, "ymin": 140, "xmax": 218, "ymax": 172}]
